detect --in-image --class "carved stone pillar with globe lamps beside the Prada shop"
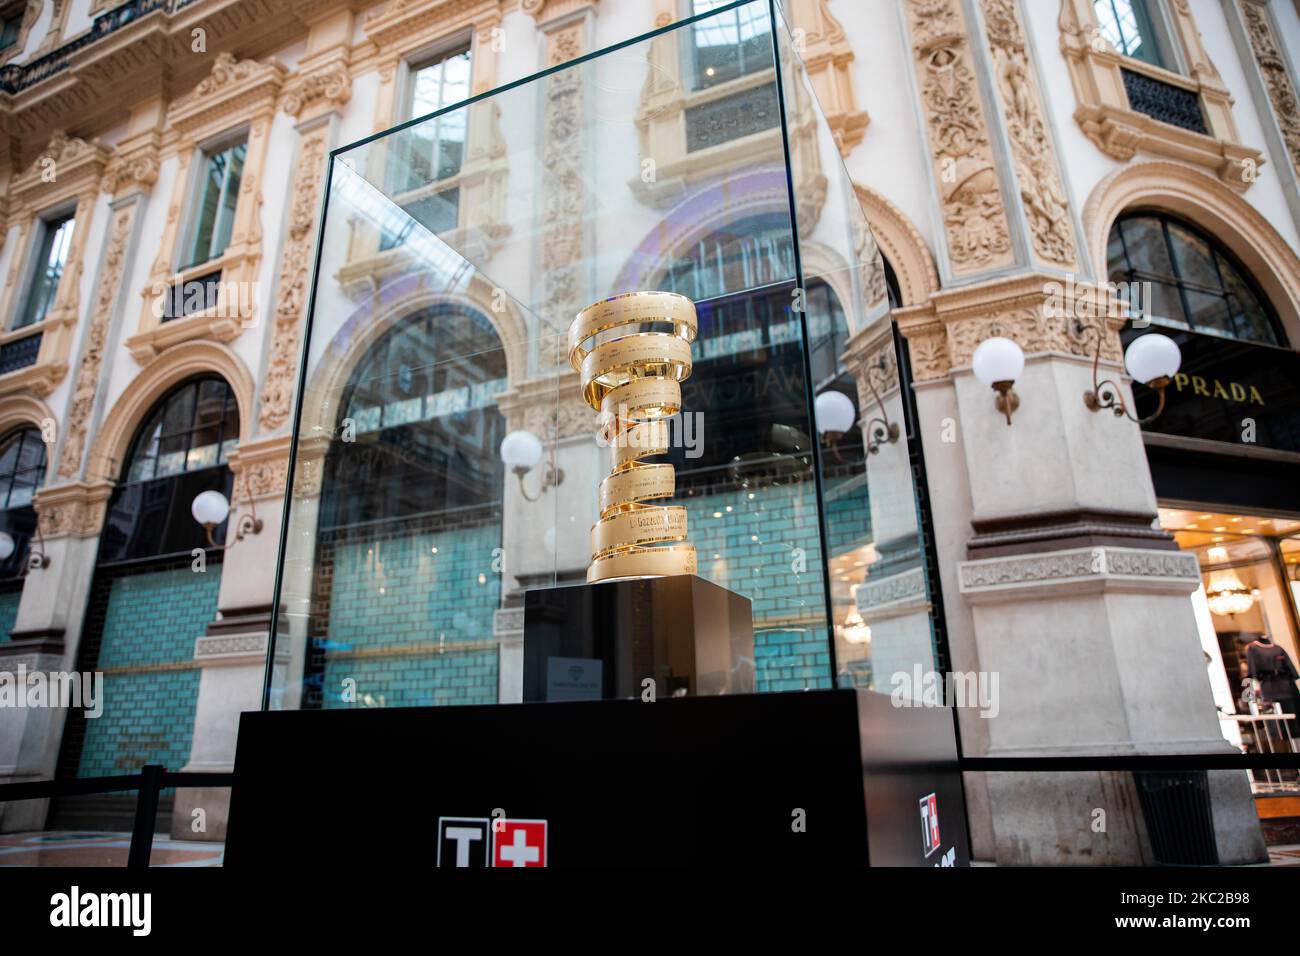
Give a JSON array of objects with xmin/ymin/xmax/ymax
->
[{"xmin": 894, "ymin": 0, "xmax": 1262, "ymax": 864}]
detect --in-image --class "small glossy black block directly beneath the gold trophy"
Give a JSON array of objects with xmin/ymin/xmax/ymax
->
[{"xmin": 524, "ymin": 575, "xmax": 754, "ymax": 701}]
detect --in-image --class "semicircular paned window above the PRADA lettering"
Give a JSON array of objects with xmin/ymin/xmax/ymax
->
[{"xmin": 1106, "ymin": 212, "xmax": 1286, "ymax": 345}]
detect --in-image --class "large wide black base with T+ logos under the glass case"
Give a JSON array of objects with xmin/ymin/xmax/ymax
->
[{"xmin": 225, "ymin": 689, "xmax": 969, "ymax": 874}]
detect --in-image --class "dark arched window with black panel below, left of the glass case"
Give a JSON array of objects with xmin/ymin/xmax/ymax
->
[{"xmin": 99, "ymin": 376, "xmax": 239, "ymax": 563}]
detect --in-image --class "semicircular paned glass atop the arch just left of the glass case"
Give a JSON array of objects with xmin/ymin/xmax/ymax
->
[{"xmin": 126, "ymin": 378, "xmax": 239, "ymax": 483}]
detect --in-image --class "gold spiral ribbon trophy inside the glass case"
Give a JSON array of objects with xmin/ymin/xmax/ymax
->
[{"xmin": 568, "ymin": 293, "xmax": 698, "ymax": 583}]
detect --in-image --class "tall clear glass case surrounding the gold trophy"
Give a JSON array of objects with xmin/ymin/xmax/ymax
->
[{"xmin": 268, "ymin": 0, "xmax": 936, "ymax": 709}]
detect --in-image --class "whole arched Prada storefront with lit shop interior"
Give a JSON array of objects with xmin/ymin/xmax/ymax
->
[{"xmin": 1110, "ymin": 211, "xmax": 1300, "ymax": 818}]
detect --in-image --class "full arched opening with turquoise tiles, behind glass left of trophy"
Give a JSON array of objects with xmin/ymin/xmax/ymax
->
[{"xmin": 303, "ymin": 303, "xmax": 506, "ymax": 708}]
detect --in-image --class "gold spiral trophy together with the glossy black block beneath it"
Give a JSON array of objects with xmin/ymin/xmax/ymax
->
[{"xmin": 523, "ymin": 293, "xmax": 754, "ymax": 701}]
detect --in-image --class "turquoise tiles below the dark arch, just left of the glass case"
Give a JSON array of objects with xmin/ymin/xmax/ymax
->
[{"xmin": 78, "ymin": 564, "xmax": 221, "ymax": 777}]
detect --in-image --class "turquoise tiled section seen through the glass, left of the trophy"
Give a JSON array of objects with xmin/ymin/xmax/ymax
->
[{"xmin": 321, "ymin": 523, "xmax": 501, "ymax": 708}]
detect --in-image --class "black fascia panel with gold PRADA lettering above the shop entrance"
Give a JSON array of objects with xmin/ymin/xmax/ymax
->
[{"xmin": 1123, "ymin": 329, "xmax": 1300, "ymax": 451}]
